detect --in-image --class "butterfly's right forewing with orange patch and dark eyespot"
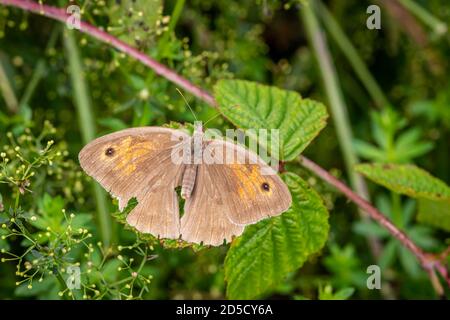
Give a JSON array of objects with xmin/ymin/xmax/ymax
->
[{"xmin": 204, "ymin": 140, "xmax": 292, "ymax": 225}]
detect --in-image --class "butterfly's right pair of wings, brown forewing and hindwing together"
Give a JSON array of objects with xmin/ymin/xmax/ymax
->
[{"xmin": 181, "ymin": 140, "xmax": 292, "ymax": 245}]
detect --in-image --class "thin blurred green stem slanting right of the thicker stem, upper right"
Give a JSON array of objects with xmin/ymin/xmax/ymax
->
[{"xmin": 317, "ymin": 1, "xmax": 389, "ymax": 108}]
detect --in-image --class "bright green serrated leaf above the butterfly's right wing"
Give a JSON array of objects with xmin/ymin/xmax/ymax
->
[{"xmin": 214, "ymin": 80, "xmax": 328, "ymax": 161}]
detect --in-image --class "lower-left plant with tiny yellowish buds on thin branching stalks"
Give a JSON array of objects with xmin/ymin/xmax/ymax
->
[{"xmin": 0, "ymin": 123, "xmax": 155, "ymax": 299}]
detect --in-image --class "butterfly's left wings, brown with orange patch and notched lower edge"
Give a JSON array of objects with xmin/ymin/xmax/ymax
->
[{"xmin": 79, "ymin": 127, "xmax": 190, "ymax": 238}]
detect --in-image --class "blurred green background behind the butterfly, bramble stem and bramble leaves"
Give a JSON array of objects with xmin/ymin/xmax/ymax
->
[{"xmin": 0, "ymin": 0, "xmax": 450, "ymax": 299}]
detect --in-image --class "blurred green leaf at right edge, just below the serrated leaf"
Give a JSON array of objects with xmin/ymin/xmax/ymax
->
[{"xmin": 417, "ymin": 199, "xmax": 450, "ymax": 231}]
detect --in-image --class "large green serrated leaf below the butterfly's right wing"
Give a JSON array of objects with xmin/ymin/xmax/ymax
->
[{"xmin": 225, "ymin": 173, "xmax": 329, "ymax": 299}]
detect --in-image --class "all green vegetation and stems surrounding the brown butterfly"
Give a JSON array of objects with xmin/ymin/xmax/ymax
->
[{"xmin": 0, "ymin": 0, "xmax": 450, "ymax": 300}]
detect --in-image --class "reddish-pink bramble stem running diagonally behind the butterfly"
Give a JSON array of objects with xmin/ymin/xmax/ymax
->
[{"xmin": 0, "ymin": 0, "xmax": 450, "ymax": 294}]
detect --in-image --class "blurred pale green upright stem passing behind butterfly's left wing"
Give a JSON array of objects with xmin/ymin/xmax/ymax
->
[{"xmin": 64, "ymin": 30, "xmax": 112, "ymax": 247}]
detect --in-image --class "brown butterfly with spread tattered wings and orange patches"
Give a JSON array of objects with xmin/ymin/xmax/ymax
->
[{"xmin": 79, "ymin": 124, "xmax": 292, "ymax": 246}]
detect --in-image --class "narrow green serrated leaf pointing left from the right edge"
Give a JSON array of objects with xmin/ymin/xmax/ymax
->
[{"xmin": 356, "ymin": 163, "xmax": 450, "ymax": 200}]
